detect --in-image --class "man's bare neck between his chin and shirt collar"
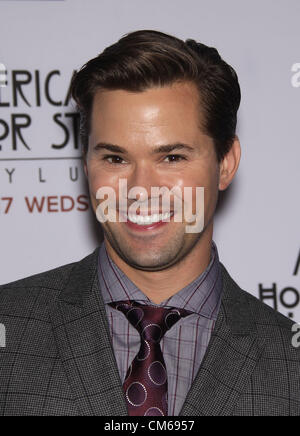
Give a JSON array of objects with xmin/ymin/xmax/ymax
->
[{"xmin": 105, "ymin": 223, "xmax": 213, "ymax": 304}]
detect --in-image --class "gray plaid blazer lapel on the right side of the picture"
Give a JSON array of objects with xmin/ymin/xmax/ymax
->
[{"xmin": 180, "ymin": 264, "xmax": 265, "ymax": 416}]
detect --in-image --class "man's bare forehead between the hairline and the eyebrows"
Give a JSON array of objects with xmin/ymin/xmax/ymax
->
[{"xmin": 91, "ymin": 82, "xmax": 201, "ymax": 131}]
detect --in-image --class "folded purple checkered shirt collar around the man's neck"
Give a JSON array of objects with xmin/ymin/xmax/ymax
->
[{"xmin": 98, "ymin": 241, "xmax": 223, "ymax": 320}]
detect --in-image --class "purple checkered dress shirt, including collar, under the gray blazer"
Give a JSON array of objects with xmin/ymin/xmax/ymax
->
[{"xmin": 98, "ymin": 242, "xmax": 223, "ymax": 416}]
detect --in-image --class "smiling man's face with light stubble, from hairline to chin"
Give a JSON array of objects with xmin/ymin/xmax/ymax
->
[{"xmin": 85, "ymin": 82, "xmax": 220, "ymax": 271}]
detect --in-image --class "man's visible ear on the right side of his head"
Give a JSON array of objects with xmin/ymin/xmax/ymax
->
[{"xmin": 219, "ymin": 136, "xmax": 241, "ymax": 191}]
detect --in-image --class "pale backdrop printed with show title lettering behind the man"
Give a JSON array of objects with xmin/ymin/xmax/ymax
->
[{"xmin": 0, "ymin": 0, "xmax": 300, "ymax": 322}]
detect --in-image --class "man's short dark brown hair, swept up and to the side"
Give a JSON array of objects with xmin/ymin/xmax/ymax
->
[{"xmin": 71, "ymin": 30, "xmax": 241, "ymax": 162}]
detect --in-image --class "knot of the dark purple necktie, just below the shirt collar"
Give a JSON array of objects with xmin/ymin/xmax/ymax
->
[{"xmin": 109, "ymin": 301, "xmax": 193, "ymax": 343}]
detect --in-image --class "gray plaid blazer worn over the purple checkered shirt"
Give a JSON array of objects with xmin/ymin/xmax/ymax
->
[{"xmin": 0, "ymin": 248, "xmax": 300, "ymax": 416}]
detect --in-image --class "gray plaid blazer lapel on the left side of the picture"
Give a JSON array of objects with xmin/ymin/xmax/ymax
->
[{"xmin": 51, "ymin": 248, "xmax": 127, "ymax": 416}]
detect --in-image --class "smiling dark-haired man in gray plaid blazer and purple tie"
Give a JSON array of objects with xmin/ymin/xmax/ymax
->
[{"xmin": 0, "ymin": 31, "xmax": 300, "ymax": 416}]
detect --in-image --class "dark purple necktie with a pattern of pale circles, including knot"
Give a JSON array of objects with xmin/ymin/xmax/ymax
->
[{"xmin": 109, "ymin": 301, "xmax": 193, "ymax": 416}]
